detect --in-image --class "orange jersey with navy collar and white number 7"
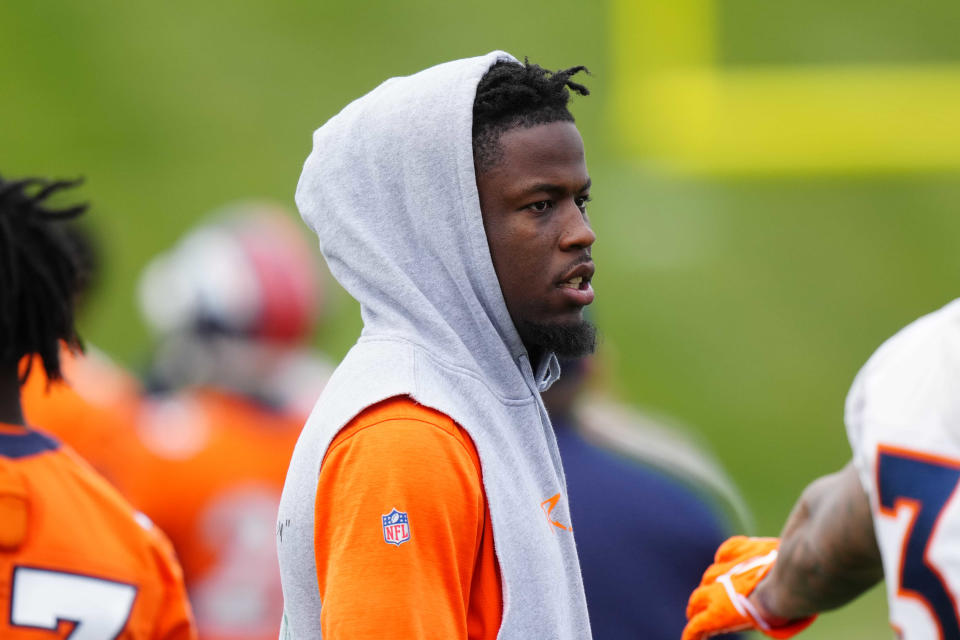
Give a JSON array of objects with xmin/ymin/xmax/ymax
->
[{"xmin": 0, "ymin": 425, "xmax": 196, "ymax": 640}]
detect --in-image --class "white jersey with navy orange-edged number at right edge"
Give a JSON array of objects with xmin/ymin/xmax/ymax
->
[{"xmin": 846, "ymin": 300, "xmax": 960, "ymax": 640}]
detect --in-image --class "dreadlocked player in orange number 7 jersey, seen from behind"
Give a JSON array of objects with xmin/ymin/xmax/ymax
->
[{"xmin": 0, "ymin": 172, "xmax": 196, "ymax": 640}]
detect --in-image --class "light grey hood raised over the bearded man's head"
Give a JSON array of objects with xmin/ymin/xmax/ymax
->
[{"xmin": 296, "ymin": 51, "xmax": 558, "ymax": 397}]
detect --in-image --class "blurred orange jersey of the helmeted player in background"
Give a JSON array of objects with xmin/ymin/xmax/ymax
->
[{"xmin": 115, "ymin": 390, "xmax": 305, "ymax": 640}]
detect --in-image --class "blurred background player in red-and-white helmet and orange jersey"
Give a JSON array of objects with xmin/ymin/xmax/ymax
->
[{"xmin": 29, "ymin": 203, "xmax": 330, "ymax": 640}]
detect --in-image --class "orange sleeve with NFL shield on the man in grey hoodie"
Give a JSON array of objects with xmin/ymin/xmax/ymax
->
[{"xmin": 314, "ymin": 397, "xmax": 503, "ymax": 640}]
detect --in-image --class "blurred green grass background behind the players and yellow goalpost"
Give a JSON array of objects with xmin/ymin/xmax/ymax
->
[{"xmin": 0, "ymin": 0, "xmax": 960, "ymax": 640}]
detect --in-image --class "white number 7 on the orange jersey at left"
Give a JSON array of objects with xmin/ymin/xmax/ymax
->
[{"xmin": 10, "ymin": 567, "xmax": 137, "ymax": 640}]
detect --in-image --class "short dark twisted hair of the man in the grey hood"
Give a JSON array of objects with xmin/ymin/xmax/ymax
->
[{"xmin": 473, "ymin": 59, "xmax": 590, "ymax": 171}]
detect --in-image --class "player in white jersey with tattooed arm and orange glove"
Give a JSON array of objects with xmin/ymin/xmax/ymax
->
[{"xmin": 683, "ymin": 300, "xmax": 960, "ymax": 640}]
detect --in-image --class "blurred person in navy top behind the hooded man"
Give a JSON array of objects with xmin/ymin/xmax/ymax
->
[{"xmin": 543, "ymin": 358, "xmax": 749, "ymax": 640}]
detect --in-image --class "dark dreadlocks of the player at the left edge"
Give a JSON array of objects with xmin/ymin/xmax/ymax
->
[{"xmin": 0, "ymin": 177, "xmax": 87, "ymax": 384}]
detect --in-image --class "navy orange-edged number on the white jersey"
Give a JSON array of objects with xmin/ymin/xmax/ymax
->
[{"xmin": 877, "ymin": 445, "xmax": 960, "ymax": 640}]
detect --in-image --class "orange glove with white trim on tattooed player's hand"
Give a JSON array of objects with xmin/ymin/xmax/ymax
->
[{"xmin": 682, "ymin": 536, "xmax": 816, "ymax": 640}]
